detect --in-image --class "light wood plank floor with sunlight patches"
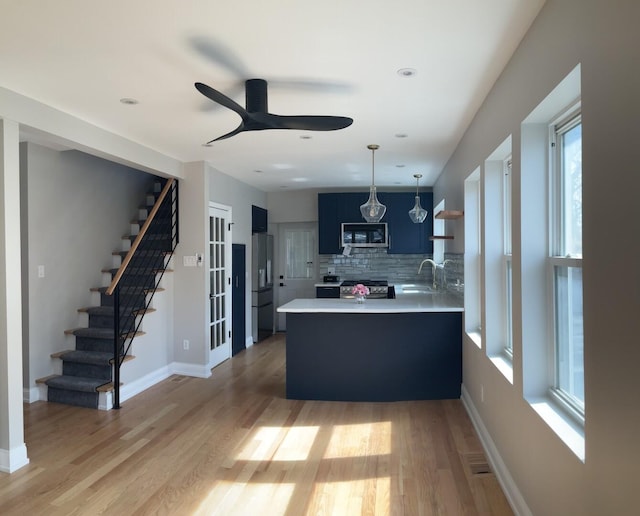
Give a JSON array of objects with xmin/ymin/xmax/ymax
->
[{"xmin": 0, "ymin": 336, "xmax": 512, "ymax": 516}]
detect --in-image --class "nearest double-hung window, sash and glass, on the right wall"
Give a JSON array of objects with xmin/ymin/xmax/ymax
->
[{"xmin": 549, "ymin": 111, "xmax": 584, "ymax": 418}]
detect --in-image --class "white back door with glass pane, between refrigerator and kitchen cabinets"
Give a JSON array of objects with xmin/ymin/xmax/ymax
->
[{"xmin": 277, "ymin": 222, "xmax": 318, "ymax": 331}]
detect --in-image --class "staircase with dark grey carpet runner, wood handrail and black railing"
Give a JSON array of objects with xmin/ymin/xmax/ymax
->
[{"xmin": 36, "ymin": 180, "xmax": 178, "ymax": 409}]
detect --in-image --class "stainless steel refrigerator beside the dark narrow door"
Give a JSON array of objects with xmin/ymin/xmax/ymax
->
[{"xmin": 251, "ymin": 233, "xmax": 274, "ymax": 342}]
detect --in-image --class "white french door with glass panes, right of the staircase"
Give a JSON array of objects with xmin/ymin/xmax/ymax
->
[{"xmin": 208, "ymin": 204, "xmax": 231, "ymax": 367}]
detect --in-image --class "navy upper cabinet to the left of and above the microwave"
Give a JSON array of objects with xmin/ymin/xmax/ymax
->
[{"xmin": 318, "ymin": 192, "xmax": 369, "ymax": 254}]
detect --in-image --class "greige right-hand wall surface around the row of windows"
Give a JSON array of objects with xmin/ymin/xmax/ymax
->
[{"xmin": 434, "ymin": 0, "xmax": 640, "ymax": 516}]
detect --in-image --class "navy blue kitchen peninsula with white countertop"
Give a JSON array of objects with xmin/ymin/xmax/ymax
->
[{"xmin": 278, "ymin": 293, "xmax": 463, "ymax": 401}]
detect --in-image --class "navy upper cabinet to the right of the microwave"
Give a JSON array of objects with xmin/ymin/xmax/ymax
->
[{"xmin": 378, "ymin": 192, "xmax": 433, "ymax": 254}]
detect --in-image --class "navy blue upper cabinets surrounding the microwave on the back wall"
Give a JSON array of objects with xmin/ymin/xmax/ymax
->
[{"xmin": 318, "ymin": 192, "xmax": 433, "ymax": 254}]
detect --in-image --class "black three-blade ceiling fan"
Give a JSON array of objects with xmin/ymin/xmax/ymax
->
[{"xmin": 195, "ymin": 79, "xmax": 353, "ymax": 144}]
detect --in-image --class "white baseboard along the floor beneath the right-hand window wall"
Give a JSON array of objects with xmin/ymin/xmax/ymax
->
[{"xmin": 460, "ymin": 385, "xmax": 533, "ymax": 516}]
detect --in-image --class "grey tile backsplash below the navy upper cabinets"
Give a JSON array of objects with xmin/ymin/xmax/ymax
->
[{"xmin": 320, "ymin": 251, "xmax": 464, "ymax": 291}]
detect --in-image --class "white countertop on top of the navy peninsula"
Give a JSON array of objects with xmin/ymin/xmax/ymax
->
[{"xmin": 277, "ymin": 293, "xmax": 464, "ymax": 314}]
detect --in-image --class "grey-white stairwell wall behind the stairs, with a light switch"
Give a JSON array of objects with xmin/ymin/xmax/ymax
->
[{"xmin": 20, "ymin": 144, "xmax": 159, "ymax": 388}]
